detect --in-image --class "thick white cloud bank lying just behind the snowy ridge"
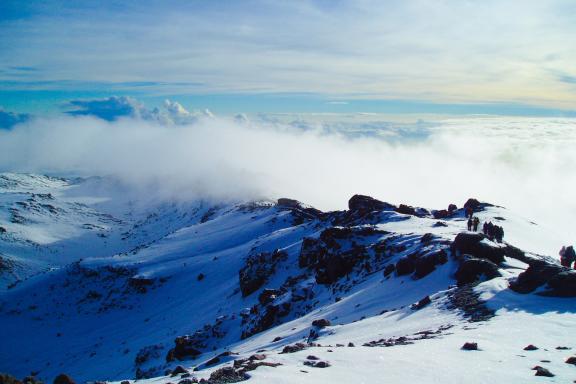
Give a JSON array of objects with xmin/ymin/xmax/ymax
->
[{"xmin": 0, "ymin": 112, "xmax": 576, "ymax": 240}]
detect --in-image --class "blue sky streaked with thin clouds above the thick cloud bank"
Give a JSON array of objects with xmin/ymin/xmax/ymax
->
[{"xmin": 0, "ymin": 0, "xmax": 576, "ymax": 115}]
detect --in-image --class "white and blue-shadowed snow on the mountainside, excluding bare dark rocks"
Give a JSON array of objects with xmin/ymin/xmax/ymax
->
[{"xmin": 0, "ymin": 174, "xmax": 576, "ymax": 384}]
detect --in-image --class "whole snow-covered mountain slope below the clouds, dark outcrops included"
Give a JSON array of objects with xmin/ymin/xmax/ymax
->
[{"xmin": 0, "ymin": 174, "xmax": 576, "ymax": 384}]
